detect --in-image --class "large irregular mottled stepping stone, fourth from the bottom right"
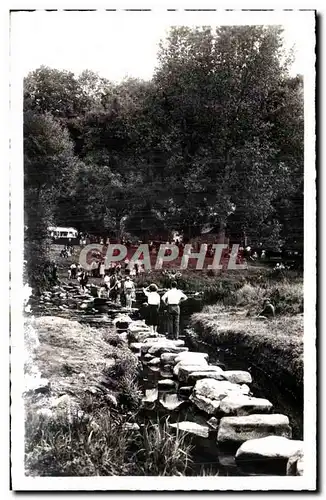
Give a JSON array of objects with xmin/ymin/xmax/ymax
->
[{"xmin": 190, "ymin": 378, "xmax": 250, "ymax": 415}]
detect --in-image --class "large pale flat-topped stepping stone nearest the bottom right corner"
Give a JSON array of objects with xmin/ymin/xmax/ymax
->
[{"xmin": 235, "ymin": 436, "xmax": 303, "ymax": 461}]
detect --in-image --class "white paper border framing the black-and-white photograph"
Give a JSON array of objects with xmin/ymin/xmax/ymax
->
[{"xmin": 10, "ymin": 0, "xmax": 316, "ymax": 491}]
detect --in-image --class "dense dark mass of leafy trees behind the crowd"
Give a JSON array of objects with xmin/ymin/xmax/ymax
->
[{"xmin": 24, "ymin": 26, "xmax": 303, "ymax": 262}]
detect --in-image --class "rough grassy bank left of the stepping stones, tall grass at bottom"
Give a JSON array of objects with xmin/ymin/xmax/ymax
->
[{"xmin": 25, "ymin": 317, "xmax": 191, "ymax": 476}]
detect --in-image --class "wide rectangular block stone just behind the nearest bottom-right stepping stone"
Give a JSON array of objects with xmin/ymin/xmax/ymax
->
[{"xmin": 217, "ymin": 414, "xmax": 292, "ymax": 444}]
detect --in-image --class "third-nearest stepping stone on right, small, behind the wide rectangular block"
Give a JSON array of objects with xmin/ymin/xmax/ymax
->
[{"xmin": 220, "ymin": 393, "xmax": 273, "ymax": 415}]
